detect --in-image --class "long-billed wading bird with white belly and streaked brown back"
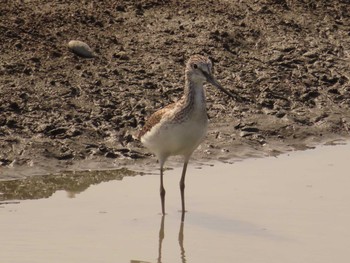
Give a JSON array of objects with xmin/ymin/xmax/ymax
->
[{"xmin": 138, "ymin": 55, "xmax": 235, "ymax": 218}]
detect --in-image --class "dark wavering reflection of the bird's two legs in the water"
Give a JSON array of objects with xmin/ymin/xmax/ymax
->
[{"xmin": 130, "ymin": 216, "xmax": 187, "ymax": 263}]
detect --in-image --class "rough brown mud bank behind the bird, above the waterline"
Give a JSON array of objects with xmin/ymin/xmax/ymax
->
[{"xmin": 0, "ymin": 0, "xmax": 350, "ymax": 179}]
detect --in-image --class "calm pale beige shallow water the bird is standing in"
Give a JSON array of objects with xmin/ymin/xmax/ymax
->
[{"xmin": 0, "ymin": 145, "xmax": 350, "ymax": 263}]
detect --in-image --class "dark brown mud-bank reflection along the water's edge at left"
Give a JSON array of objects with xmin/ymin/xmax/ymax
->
[{"xmin": 0, "ymin": 168, "xmax": 136, "ymax": 204}]
